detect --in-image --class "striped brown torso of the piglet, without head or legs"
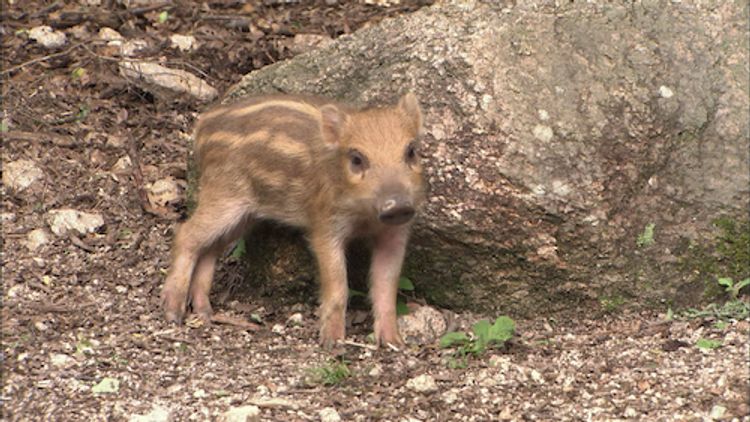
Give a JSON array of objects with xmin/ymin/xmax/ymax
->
[{"xmin": 195, "ymin": 96, "xmax": 334, "ymax": 226}]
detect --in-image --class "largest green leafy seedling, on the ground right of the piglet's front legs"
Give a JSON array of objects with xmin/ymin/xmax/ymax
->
[{"xmin": 440, "ymin": 315, "xmax": 516, "ymax": 367}]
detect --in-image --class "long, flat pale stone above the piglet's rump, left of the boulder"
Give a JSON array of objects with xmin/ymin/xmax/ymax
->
[{"xmin": 119, "ymin": 61, "xmax": 219, "ymax": 101}]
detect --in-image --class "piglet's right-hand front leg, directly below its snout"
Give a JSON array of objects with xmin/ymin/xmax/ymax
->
[{"xmin": 370, "ymin": 226, "xmax": 409, "ymax": 346}]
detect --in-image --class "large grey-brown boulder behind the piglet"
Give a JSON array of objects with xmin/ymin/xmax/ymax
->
[{"xmin": 220, "ymin": 0, "xmax": 749, "ymax": 314}]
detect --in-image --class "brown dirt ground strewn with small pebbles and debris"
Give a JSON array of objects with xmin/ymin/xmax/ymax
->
[{"xmin": 0, "ymin": 0, "xmax": 750, "ymax": 421}]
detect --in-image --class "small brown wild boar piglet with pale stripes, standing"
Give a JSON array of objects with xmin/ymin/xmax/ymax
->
[{"xmin": 162, "ymin": 94, "xmax": 424, "ymax": 345}]
